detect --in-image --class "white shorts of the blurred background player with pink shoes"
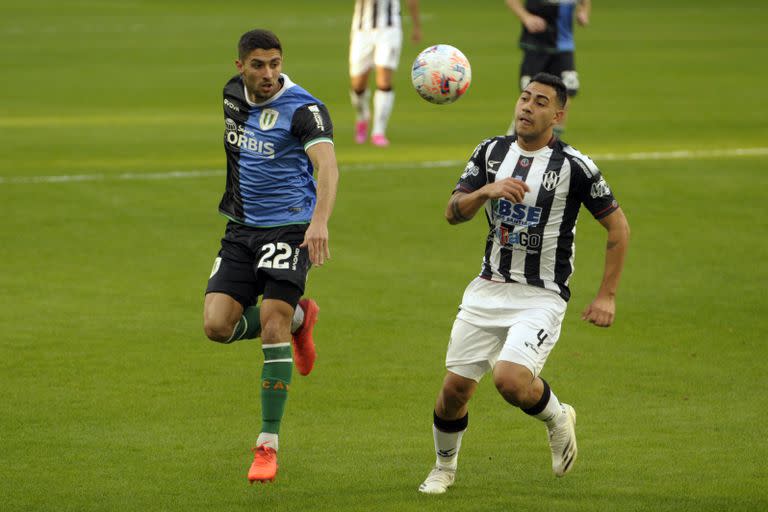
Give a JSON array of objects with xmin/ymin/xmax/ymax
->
[{"xmin": 349, "ymin": 27, "xmax": 403, "ymax": 76}]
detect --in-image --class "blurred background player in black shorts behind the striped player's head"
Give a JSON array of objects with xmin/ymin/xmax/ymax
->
[{"xmin": 506, "ymin": 0, "xmax": 592, "ymax": 135}]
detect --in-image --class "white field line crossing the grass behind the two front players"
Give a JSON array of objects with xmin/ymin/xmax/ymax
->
[{"xmin": 0, "ymin": 147, "xmax": 768, "ymax": 185}]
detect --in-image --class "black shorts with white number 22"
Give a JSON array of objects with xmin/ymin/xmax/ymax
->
[{"xmin": 205, "ymin": 222, "xmax": 311, "ymax": 308}]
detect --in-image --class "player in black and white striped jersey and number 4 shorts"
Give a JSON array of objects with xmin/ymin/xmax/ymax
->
[{"xmin": 419, "ymin": 73, "xmax": 629, "ymax": 494}]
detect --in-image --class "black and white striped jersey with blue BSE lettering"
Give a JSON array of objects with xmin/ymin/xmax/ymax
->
[{"xmin": 454, "ymin": 136, "xmax": 619, "ymax": 301}]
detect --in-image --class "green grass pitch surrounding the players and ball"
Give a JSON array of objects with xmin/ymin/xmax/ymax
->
[{"xmin": 0, "ymin": 0, "xmax": 768, "ymax": 512}]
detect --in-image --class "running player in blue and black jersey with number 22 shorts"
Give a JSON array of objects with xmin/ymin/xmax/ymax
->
[{"xmin": 203, "ymin": 30, "xmax": 339, "ymax": 482}]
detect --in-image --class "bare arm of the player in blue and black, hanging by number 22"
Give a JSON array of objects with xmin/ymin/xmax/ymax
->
[{"xmin": 301, "ymin": 142, "xmax": 339, "ymax": 266}]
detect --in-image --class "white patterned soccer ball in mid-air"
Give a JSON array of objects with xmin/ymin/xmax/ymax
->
[{"xmin": 411, "ymin": 44, "xmax": 472, "ymax": 105}]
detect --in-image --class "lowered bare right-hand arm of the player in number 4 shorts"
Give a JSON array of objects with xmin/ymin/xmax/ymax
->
[{"xmin": 581, "ymin": 208, "xmax": 629, "ymax": 327}]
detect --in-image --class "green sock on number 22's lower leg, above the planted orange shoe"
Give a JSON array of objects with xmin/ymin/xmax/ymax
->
[{"xmin": 261, "ymin": 342, "xmax": 293, "ymax": 434}]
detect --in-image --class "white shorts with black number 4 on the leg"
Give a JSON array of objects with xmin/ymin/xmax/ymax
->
[{"xmin": 445, "ymin": 277, "xmax": 568, "ymax": 382}]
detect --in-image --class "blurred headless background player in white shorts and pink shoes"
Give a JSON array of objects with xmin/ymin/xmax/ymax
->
[{"xmin": 349, "ymin": 0, "xmax": 421, "ymax": 147}]
